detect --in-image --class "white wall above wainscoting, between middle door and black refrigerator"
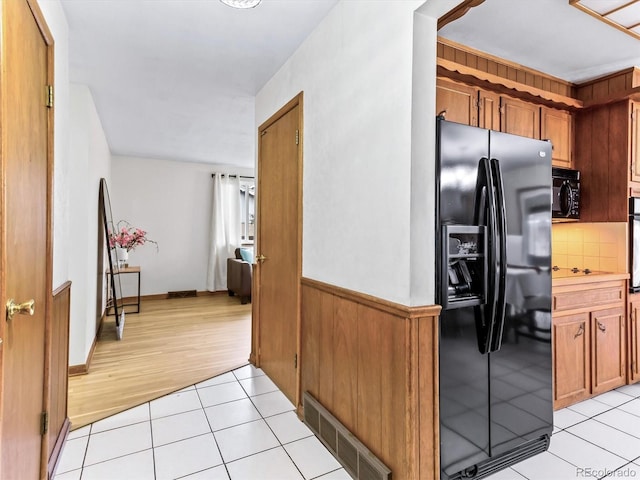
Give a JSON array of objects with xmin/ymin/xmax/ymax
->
[{"xmin": 256, "ymin": 0, "xmax": 450, "ymax": 305}]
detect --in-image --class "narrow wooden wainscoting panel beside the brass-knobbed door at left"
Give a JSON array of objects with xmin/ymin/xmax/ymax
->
[{"xmin": 47, "ymin": 282, "xmax": 71, "ymax": 478}]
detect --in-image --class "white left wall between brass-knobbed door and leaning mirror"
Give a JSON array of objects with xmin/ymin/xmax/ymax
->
[{"xmin": 38, "ymin": 0, "xmax": 110, "ymax": 365}]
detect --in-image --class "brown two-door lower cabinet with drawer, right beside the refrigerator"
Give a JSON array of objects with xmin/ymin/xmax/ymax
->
[{"xmin": 552, "ymin": 280, "xmax": 628, "ymax": 409}]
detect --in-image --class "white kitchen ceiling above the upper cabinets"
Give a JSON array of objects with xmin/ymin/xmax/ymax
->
[{"xmin": 438, "ymin": 0, "xmax": 640, "ymax": 83}]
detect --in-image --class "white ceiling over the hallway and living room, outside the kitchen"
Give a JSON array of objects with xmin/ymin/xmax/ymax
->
[{"xmin": 61, "ymin": 0, "xmax": 337, "ymax": 168}]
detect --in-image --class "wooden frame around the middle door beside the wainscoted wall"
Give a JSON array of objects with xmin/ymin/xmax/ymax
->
[{"xmin": 249, "ymin": 91, "xmax": 304, "ymax": 407}]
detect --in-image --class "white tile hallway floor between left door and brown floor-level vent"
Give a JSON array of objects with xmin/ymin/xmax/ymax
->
[{"xmin": 55, "ymin": 365, "xmax": 351, "ymax": 480}]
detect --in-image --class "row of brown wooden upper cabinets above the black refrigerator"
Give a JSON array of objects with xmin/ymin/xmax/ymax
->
[{"xmin": 436, "ymin": 78, "xmax": 576, "ymax": 168}]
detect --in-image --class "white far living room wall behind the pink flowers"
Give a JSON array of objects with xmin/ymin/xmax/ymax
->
[{"xmin": 110, "ymin": 156, "xmax": 253, "ymax": 296}]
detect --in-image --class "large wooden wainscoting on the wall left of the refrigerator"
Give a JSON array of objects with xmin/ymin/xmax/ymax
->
[{"xmin": 298, "ymin": 278, "xmax": 440, "ymax": 480}]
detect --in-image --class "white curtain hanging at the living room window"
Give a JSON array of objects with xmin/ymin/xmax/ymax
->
[{"xmin": 207, "ymin": 173, "xmax": 240, "ymax": 292}]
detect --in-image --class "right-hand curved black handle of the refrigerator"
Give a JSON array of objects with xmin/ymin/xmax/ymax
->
[{"xmin": 489, "ymin": 158, "xmax": 507, "ymax": 352}]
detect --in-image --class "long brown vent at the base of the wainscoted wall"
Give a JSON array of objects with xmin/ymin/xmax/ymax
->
[{"xmin": 302, "ymin": 392, "xmax": 391, "ymax": 480}]
